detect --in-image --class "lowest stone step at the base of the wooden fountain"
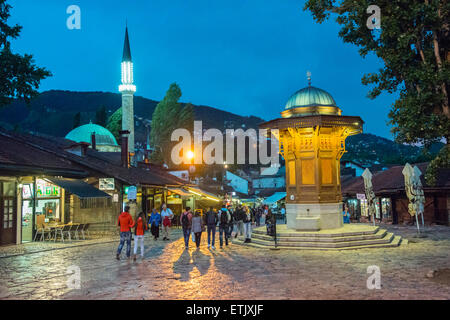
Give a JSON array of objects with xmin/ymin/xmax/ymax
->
[{"xmin": 233, "ymin": 233, "xmax": 402, "ymax": 251}]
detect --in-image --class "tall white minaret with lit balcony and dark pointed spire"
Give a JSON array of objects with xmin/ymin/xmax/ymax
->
[{"xmin": 119, "ymin": 27, "xmax": 136, "ymax": 154}]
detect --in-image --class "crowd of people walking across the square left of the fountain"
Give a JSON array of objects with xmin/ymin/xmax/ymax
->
[{"xmin": 116, "ymin": 204, "xmax": 275, "ymax": 261}]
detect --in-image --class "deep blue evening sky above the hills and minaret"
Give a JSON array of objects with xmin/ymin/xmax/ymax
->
[{"xmin": 9, "ymin": 0, "xmax": 396, "ymax": 138}]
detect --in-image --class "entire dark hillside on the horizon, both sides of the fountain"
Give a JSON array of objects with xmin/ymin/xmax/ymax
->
[{"xmin": 0, "ymin": 90, "xmax": 442, "ymax": 164}]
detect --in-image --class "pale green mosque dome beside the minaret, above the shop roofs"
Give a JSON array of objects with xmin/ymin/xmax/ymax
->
[{"xmin": 66, "ymin": 123, "xmax": 118, "ymax": 146}]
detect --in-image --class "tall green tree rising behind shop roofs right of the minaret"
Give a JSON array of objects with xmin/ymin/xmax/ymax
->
[{"xmin": 150, "ymin": 83, "xmax": 194, "ymax": 166}]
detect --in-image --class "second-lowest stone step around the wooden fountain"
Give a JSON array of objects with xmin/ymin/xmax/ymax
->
[{"xmin": 252, "ymin": 229, "xmax": 387, "ymax": 242}]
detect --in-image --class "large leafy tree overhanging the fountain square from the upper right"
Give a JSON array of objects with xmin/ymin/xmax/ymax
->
[{"xmin": 304, "ymin": 0, "xmax": 450, "ymax": 182}]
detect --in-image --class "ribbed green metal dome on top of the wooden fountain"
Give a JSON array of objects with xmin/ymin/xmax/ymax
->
[{"xmin": 285, "ymin": 86, "xmax": 337, "ymax": 109}]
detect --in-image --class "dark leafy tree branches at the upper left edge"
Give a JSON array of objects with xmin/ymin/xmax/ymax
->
[{"xmin": 0, "ymin": 0, "xmax": 51, "ymax": 107}]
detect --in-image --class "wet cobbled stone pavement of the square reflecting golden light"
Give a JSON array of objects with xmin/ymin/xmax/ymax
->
[{"xmin": 0, "ymin": 226, "xmax": 450, "ymax": 300}]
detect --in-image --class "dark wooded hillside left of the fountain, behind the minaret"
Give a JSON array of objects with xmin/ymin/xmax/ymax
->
[{"xmin": 0, "ymin": 90, "xmax": 264, "ymax": 141}]
